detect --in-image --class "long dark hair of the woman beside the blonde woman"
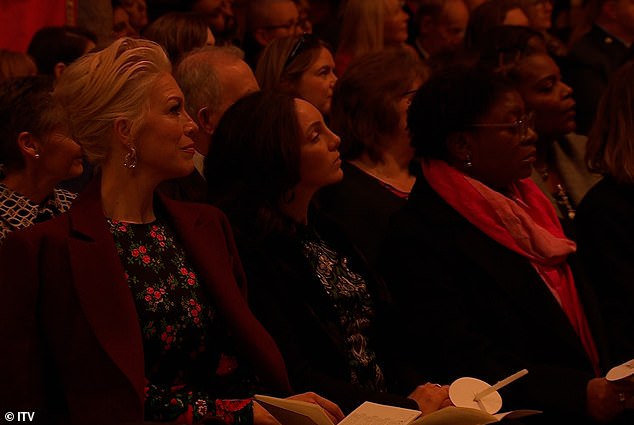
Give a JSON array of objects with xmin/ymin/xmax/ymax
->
[{"xmin": 204, "ymin": 91, "xmax": 302, "ymax": 240}]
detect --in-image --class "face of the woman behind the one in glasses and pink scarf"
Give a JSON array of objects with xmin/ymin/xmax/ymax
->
[{"xmin": 519, "ymin": 54, "xmax": 576, "ymax": 137}]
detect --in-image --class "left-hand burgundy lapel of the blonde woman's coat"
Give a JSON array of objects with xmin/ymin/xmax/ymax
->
[{"xmin": 68, "ymin": 179, "xmax": 145, "ymax": 403}]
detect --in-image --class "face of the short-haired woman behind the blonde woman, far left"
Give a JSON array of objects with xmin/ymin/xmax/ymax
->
[{"xmin": 38, "ymin": 129, "xmax": 84, "ymax": 182}]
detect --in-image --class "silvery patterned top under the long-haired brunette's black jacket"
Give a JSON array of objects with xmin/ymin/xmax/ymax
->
[{"xmin": 303, "ymin": 229, "xmax": 385, "ymax": 391}]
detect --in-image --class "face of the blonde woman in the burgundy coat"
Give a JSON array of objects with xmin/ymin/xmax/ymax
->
[{"xmin": 133, "ymin": 73, "xmax": 198, "ymax": 181}]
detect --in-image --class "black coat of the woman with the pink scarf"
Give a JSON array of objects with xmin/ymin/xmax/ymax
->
[{"xmin": 380, "ymin": 177, "xmax": 603, "ymax": 424}]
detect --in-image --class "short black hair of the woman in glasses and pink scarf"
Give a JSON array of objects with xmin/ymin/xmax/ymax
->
[{"xmin": 407, "ymin": 65, "xmax": 515, "ymax": 162}]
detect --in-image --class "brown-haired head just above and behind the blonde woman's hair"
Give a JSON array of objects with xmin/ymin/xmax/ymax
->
[{"xmin": 143, "ymin": 12, "xmax": 216, "ymax": 66}]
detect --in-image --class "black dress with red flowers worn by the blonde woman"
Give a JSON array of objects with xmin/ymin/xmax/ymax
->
[{"xmin": 108, "ymin": 220, "xmax": 255, "ymax": 424}]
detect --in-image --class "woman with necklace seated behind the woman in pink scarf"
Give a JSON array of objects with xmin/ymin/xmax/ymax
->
[{"xmin": 480, "ymin": 26, "xmax": 600, "ymax": 232}]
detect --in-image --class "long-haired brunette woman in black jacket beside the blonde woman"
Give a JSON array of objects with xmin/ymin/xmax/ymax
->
[{"xmin": 205, "ymin": 92, "xmax": 449, "ymax": 413}]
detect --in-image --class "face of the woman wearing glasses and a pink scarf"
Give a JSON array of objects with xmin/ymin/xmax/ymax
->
[{"xmin": 466, "ymin": 91, "xmax": 536, "ymax": 189}]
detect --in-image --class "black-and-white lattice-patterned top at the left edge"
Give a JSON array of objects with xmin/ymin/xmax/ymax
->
[{"xmin": 0, "ymin": 183, "xmax": 77, "ymax": 244}]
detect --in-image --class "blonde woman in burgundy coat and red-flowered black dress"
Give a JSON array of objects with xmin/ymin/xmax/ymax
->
[{"xmin": 0, "ymin": 39, "xmax": 342, "ymax": 424}]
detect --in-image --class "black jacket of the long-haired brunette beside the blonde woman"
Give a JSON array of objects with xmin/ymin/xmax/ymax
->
[{"xmin": 236, "ymin": 210, "xmax": 418, "ymax": 412}]
